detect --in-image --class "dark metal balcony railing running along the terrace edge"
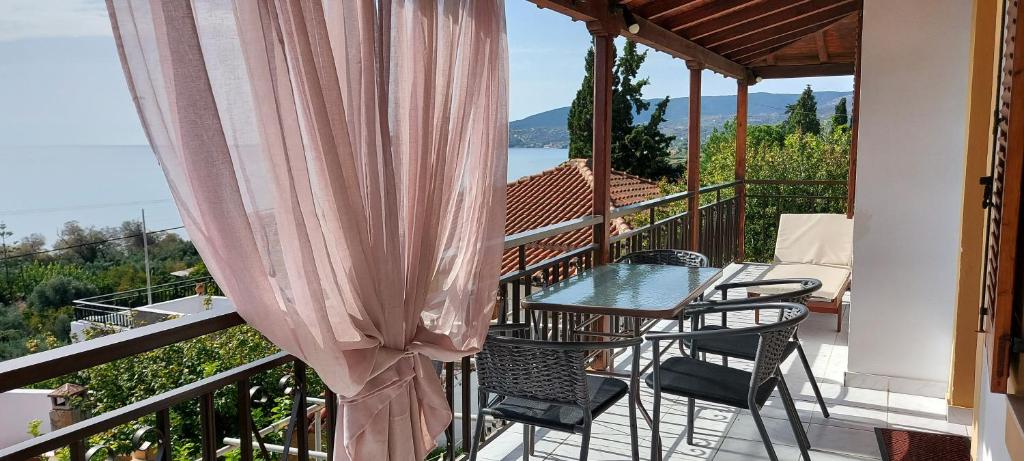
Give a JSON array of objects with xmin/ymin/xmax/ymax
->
[{"xmin": 0, "ymin": 181, "xmax": 845, "ymax": 461}]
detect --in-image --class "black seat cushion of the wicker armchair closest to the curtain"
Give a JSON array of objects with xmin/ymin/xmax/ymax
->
[{"xmin": 483, "ymin": 376, "xmax": 629, "ymax": 431}]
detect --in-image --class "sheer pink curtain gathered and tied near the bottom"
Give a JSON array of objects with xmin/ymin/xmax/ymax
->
[{"xmin": 108, "ymin": 0, "xmax": 508, "ymax": 461}]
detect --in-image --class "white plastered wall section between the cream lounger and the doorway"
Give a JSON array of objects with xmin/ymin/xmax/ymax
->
[{"xmin": 847, "ymin": 0, "xmax": 972, "ymax": 396}]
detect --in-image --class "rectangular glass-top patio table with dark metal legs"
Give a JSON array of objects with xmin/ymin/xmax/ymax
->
[{"xmin": 522, "ymin": 264, "xmax": 722, "ymax": 436}]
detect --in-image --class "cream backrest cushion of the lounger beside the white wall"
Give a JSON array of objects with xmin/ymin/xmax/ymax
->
[{"xmin": 775, "ymin": 214, "xmax": 853, "ymax": 268}]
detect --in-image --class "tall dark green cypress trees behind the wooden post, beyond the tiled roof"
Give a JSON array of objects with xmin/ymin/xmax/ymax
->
[{"xmin": 567, "ymin": 41, "xmax": 682, "ymax": 179}]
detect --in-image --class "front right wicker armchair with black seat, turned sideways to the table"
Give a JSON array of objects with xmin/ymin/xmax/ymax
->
[{"xmin": 646, "ymin": 302, "xmax": 810, "ymax": 461}]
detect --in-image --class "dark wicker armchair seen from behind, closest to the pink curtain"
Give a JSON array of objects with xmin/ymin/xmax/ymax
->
[{"xmin": 469, "ymin": 324, "xmax": 643, "ymax": 461}]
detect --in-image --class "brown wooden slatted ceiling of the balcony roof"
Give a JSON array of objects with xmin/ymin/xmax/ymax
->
[{"xmin": 529, "ymin": 0, "xmax": 863, "ymax": 80}]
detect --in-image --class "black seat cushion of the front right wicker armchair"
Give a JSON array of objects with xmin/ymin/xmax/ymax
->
[{"xmin": 645, "ymin": 357, "xmax": 777, "ymax": 409}]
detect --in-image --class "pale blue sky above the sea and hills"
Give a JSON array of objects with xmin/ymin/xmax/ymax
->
[{"xmin": 0, "ymin": 0, "xmax": 853, "ymax": 145}]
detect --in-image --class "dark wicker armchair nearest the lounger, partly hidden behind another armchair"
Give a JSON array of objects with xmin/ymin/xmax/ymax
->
[{"xmin": 692, "ymin": 279, "xmax": 829, "ymax": 418}]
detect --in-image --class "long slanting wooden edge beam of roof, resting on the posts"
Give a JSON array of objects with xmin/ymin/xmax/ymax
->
[{"xmin": 528, "ymin": 0, "xmax": 749, "ymax": 79}]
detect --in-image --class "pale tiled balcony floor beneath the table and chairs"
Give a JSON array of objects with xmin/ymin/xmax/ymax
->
[{"xmin": 479, "ymin": 264, "xmax": 967, "ymax": 461}]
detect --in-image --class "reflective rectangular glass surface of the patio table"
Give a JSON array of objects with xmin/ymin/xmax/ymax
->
[{"xmin": 522, "ymin": 264, "xmax": 722, "ymax": 318}]
